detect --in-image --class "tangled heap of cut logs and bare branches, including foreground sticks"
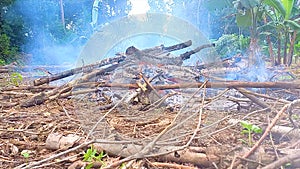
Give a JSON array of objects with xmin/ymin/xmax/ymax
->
[{"xmin": 0, "ymin": 41, "xmax": 300, "ymax": 168}]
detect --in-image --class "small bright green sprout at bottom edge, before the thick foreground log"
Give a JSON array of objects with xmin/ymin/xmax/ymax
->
[{"xmin": 83, "ymin": 146, "xmax": 106, "ymax": 169}]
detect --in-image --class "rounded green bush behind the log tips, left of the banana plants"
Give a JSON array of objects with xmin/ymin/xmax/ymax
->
[{"xmin": 215, "ymin": 34, "xmax": 250, "ymax": 58}]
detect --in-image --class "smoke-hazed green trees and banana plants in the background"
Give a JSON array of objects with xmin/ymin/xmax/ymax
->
[{"xmin": 0, "ymin": 0, "xmax": 300, "ymax": 65}]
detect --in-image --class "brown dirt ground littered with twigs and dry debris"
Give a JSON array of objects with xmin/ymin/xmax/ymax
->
[{"xmin": 0, "ymin": 65, "xmax": 300, "ymax": 169}]
